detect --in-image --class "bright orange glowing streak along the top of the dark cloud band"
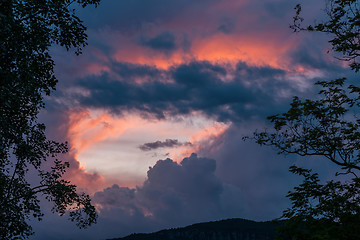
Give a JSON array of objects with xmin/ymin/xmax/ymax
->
[{"xmin": 106, "ymin": 28, "xmax": 297, "ymax": 73}]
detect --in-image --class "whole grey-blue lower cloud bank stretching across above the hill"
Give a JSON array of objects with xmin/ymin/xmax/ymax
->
[{"xmin": 34, "ymin": 113, "xmax": 352, "ymax": 240}]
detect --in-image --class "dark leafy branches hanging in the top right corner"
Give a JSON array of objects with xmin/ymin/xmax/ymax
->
[{"xmin": 291, "ymin": 0, "xmax": 360, "ymax": 72}]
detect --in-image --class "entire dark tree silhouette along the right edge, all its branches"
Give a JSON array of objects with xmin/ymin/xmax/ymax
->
[{"xmin": 250, "ymin": 0, "xmax": 360, "ymax": 240}]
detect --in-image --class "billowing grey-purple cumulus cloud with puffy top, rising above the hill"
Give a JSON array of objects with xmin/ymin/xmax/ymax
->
[{"xmin": 93, "ymin": 154, "xmax": 245, "ymax": 231}]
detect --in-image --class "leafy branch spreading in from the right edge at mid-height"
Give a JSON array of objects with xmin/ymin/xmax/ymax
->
[{"xmin": 254, "ymin": 79, "xmax": 360, "ymax": 174}]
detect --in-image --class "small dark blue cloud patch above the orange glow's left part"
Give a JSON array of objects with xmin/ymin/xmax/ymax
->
[{"xmin": 140, "ymin": 31, "xmax": 176, "ymax": 51}]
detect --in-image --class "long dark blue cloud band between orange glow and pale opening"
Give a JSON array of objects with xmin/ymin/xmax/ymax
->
[{"xmin": 75, "ymin": 61, "xmax": 295, "ymax": 121}]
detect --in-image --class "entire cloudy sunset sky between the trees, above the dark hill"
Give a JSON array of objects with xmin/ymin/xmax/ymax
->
[{"xmin": 31, "ymin": 0, "xmax": 349, "ymax": 240}]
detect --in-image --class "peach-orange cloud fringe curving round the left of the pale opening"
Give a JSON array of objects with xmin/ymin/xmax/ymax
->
[{"xmin": 67, "ymin": 109, "xmax": 149, "ymax": 193}]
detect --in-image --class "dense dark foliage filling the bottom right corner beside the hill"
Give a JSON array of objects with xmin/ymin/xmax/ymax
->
[{"xmin": 277, "ymin": 166, "xmax": 360, "ymax": 240}]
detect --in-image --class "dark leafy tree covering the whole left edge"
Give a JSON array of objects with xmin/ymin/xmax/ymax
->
[{"xmin": 0, "ymin": 0, "xmax": 100, "ymax": 239}]
